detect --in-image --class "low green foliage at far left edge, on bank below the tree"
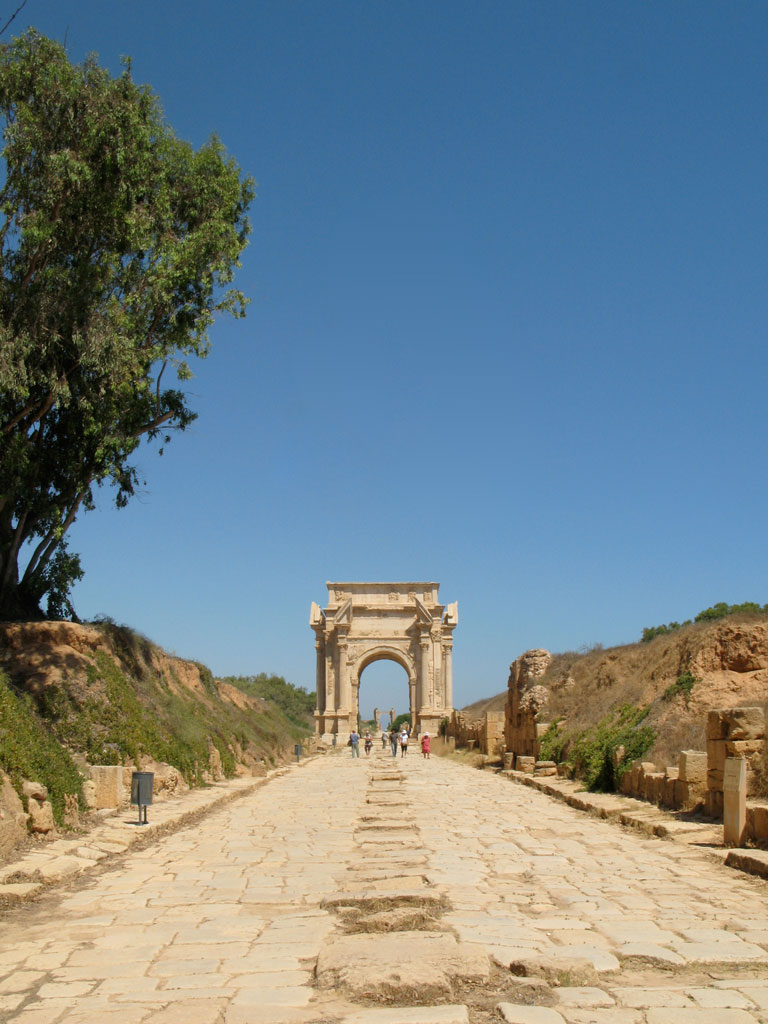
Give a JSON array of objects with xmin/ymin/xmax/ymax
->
[{"xmin": 0, "ymin": 672, "xmax": 85, "ymax": 824}]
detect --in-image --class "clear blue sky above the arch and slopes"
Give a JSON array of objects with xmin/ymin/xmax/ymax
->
[{"xmin": 18, "ymin": 0, "xmax": 768, "ymax": 711}]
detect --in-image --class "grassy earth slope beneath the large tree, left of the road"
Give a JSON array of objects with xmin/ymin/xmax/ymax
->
[{"xmin": 0, "ymin": 622, "xmax": 312, "ymax": 846}]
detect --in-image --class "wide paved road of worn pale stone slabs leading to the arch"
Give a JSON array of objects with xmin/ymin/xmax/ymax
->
[{"xmin": 0, "ymin": 750, "xmax": 768, "ymax": 1024}]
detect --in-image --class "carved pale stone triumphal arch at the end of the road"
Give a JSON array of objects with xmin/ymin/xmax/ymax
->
[{"xmin": 309, "ymin": 583, "xmax": 459, "ymax": 742}]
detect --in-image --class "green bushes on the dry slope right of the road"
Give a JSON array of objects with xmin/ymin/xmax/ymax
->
[{"xmin": 542, "ymin": 705, "xmax": 655, "ymax": 793}]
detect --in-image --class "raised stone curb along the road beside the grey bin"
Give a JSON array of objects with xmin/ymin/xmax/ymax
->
[{"xmin": 0, "ymin": 755, "xmax": 316, "ymax": 913}]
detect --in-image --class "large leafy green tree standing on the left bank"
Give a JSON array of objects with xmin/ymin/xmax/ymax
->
[{"xmin": 0, "ymin": 31, "xmax": 253, "ymax": 617}]
